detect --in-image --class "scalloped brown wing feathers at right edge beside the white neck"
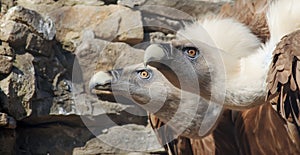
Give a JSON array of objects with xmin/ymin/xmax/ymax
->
[{"xmin": 267, "ymin": 31, "xmax": 300, "ymax": 136}]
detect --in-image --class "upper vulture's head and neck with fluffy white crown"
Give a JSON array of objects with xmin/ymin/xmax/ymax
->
[{"xmin": 144, "ymin": 19, "xmax": 266, "ymax": 109}]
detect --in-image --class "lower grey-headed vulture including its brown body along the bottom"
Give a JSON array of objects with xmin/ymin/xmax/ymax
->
[{"xmin": 90, "ymin": 64, "xmax": 300, "ymax": 154}]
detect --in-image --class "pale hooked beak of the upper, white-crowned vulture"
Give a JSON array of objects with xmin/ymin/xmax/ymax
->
[{"xmin": 144, "ymin": 44, "xmax": 172, "ymax": 66}]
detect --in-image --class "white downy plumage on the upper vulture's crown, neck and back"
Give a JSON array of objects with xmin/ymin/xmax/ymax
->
[{"xmin": 179, "ymin": 0, "xmax": 300, "ymax": 109}]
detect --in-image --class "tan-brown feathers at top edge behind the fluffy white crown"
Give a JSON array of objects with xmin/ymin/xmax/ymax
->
[{"xmin": 220, "ymin": 0, "xmax": 270, "ymax": 42}]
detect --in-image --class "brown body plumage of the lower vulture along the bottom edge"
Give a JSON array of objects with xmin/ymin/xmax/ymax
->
[{"xmin": 150, "ymin": 103, "xmax": 300, "ymax": 155}]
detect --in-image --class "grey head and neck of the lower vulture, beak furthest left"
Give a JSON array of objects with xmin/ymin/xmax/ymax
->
[{"xmin": 89, "ymin": 64, "xmax": 222, "ymax": 138}]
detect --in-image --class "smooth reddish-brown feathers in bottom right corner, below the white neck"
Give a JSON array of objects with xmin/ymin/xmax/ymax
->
[{"xmin": 235, "ymin": 104, "xmax": 300, "ymax": 155}]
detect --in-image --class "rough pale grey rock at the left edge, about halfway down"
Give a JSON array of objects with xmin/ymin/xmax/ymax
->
[{"xmin": 0, "ymin": 53, "xmax": 35, "ymax": 120}]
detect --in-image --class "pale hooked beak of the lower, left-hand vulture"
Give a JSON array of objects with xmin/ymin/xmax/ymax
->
[{"xmin": 89, "ymin": 69, "xmax": 122, "ymax": 94}]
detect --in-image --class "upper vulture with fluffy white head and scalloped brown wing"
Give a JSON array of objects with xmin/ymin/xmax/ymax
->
[{"xmin": 144, "ymin": 0, "xmax": 300, "ymax": 129}]
